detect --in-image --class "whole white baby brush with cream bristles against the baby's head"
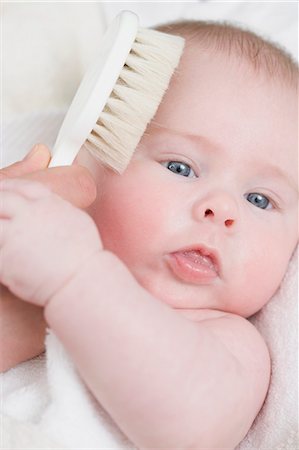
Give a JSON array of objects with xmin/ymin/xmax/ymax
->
[{"xmin": 49, "ymin": 11, "xmax": 184, "ymax": 173}]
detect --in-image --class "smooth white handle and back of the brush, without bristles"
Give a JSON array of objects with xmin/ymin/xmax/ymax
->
[{"xmin": 49, "ymin": 11, "xmax": 139, "ymax": 167}]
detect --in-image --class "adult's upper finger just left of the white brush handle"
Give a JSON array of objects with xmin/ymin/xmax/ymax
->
[{"xmin": 0, "ymin": 144, "xmax": 51, "ymax": 180}]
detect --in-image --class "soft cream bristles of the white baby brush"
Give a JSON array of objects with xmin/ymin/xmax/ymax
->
[{"xmin": 84, "ymin": 28, "xmax": 184, "ymax": 173}]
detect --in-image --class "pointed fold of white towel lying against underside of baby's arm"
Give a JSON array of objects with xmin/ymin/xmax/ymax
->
[{"xmin": 40, "ymin": 332, "xmax": 134, "ymax": 450}]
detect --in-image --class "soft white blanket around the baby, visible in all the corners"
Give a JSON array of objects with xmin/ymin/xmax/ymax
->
[{"xmin": 1, "ymin": 1, "xmax": 299, "ymax": 450}]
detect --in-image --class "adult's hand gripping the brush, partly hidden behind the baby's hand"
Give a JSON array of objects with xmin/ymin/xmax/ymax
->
[{"xmin": 0, "ymin": 144, "xmax": 96, "ymax": 372}]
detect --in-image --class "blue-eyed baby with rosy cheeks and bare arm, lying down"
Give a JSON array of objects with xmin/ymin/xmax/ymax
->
[{"xmin": 0, "ymin": 22, "xmax": 298, "ymax": 449}]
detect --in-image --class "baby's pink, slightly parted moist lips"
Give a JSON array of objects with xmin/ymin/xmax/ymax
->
[{"xmin": 166, "ymin": 245, "xmax": 220, "ymax": 285}]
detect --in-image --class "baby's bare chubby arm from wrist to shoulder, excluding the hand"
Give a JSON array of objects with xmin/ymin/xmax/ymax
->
[{"xmin": 46, "ymin": 252, "xmax": 269, "ymax": 450}]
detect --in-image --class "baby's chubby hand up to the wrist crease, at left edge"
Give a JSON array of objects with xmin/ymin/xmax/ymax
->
[{"xmin": 0, "ymin": 179, "xmax": 102, "ymax": 306}]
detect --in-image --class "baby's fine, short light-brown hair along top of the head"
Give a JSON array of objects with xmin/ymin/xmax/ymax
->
[{"xmin": 155, "ymin": 20, "xmax": 298, "ymax": 87}]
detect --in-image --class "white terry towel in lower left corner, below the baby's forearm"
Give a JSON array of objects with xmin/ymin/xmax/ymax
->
[{"xmin": 1, "ymin": 332, "xmax": 135, "ymax": 450}]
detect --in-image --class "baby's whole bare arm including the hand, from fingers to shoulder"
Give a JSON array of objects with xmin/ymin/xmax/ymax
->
[{"xmin": 0, "ymin": 178, "xmax": 269, "ymax": 450}]
